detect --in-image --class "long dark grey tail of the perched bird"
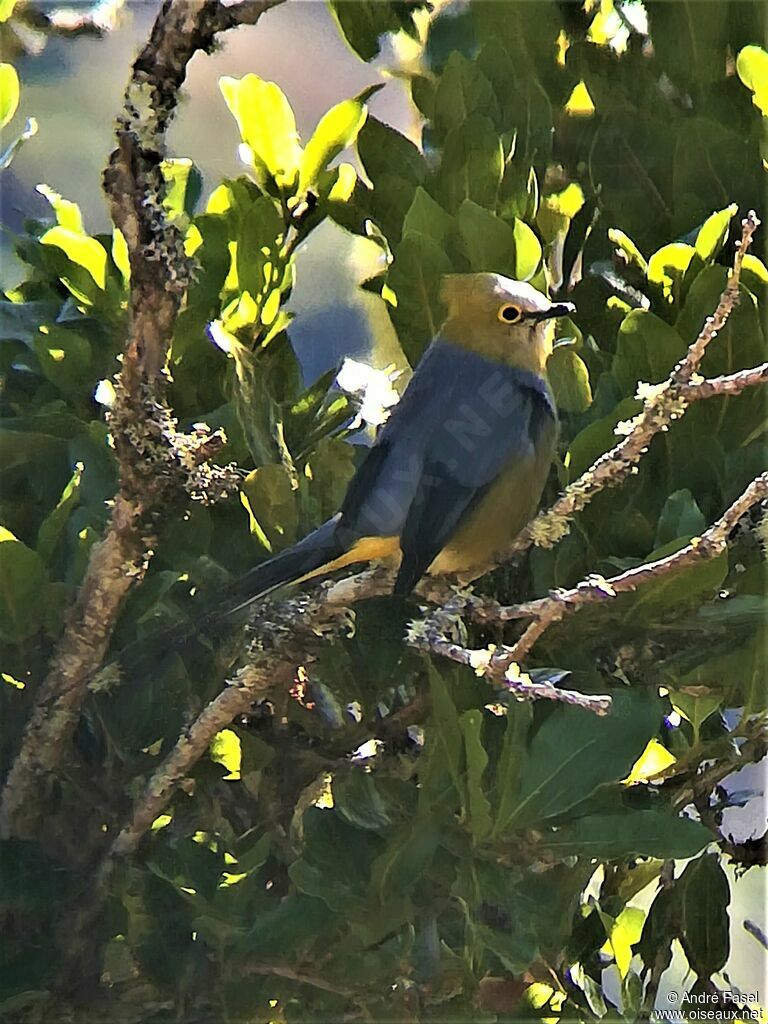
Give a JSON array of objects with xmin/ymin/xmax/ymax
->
[{"xmin": 112, "ymin": 516, "xmax": 345, "ymax": 674}]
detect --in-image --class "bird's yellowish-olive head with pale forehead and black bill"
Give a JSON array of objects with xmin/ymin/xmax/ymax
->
[{"xmin": 440, "ymin": 273, "xmax": 574, "ymax": 374}]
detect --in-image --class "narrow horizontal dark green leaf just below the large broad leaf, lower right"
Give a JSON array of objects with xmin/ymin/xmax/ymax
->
[{"xmin": 542, "ymin": 808, "xmax": 713, "ymax": 860}]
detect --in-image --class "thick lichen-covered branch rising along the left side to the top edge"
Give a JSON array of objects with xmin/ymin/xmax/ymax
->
[{"xmin": 0, "ymin": 0, "xmax": 281, "ymax": 837}]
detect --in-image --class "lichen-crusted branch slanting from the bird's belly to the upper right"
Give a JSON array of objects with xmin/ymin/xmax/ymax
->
[{"xmin": 502, "ymin": 211, "xmax": 760, "ymax": 559}]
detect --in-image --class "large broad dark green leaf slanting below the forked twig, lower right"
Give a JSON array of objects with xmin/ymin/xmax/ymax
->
[{"xmin": 508, "ymin": 692, "xmax": 660, "ymax": 827}]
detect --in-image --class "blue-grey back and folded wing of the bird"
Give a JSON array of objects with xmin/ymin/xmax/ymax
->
[{"xmin": 339, "ymin": 340, "xmax": 555, "ymax": 592}]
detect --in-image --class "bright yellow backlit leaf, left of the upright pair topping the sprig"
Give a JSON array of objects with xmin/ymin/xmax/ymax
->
[{"xmin": 219, "ymin": 74, "xmax": 302, "ymax": 190}]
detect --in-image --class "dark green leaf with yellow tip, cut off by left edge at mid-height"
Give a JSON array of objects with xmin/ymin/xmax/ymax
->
[{"xmin": 0, "ymin": 526, "xmax": 45, "ymax": 643}]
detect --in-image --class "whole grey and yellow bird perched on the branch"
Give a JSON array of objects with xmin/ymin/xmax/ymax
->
[{"xmin": 213, "ymin": 273, "xmax": 573, "ymax": 615}]
